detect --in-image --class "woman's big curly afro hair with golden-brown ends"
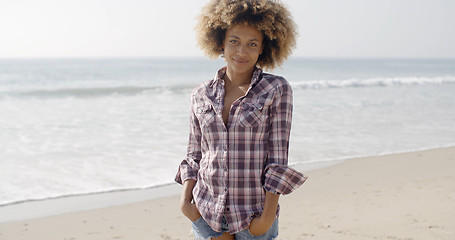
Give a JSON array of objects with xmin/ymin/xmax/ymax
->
[{"xmin": 195, "ymin": 0, "xmax": 297, "ymax": 70}]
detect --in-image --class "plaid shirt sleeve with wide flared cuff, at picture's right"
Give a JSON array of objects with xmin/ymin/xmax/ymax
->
[{"xmin": 264, "ymin": 79, "xmax": 307, "ymax": 194}]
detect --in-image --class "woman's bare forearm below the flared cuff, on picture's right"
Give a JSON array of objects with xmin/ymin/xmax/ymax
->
[{"xmin": 250, "ymin": 192, "xmax": 280, "ymax": 236}]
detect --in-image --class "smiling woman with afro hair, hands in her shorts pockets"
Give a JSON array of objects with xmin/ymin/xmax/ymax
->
[{"xmin": 175, "ymin": 0, "xmax": 306, "ymax": 239}]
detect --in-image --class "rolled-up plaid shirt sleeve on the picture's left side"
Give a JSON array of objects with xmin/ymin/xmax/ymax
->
[{"xmin": 175, "ymin": 94, "xmax": 202, "ymax": 184}]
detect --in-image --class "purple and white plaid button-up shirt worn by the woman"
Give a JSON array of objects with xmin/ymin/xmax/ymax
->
[{"xmin": 175, "ymin": 67, "xmax": 306, "ymax": 233}]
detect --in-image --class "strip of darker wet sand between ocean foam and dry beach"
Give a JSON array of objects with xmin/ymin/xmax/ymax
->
[{"xmin": 0, "ymin": 145, "xmax": 455, "ymax": 221}]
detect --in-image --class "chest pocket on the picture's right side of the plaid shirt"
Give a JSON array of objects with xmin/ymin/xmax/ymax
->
[{"xmin": 239, "ymin": 93, "xmax": 273, "ymax": 127}]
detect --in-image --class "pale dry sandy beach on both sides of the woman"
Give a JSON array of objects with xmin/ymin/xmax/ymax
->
[{"xmin": 0, "ymin": 147, "xmax": 455, "ymax": 240}]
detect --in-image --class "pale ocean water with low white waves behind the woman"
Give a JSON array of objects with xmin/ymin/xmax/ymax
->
[{"xmin": 0, "ymin": 58, "xmax": 455, "ymax": 206}]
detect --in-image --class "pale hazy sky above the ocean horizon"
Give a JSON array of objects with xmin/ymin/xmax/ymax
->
[{"xmin": 0, "ymin": 0, "xmax": 455, "ymax": 58}]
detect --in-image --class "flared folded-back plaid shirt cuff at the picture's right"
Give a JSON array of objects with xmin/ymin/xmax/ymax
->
[{"xmin": 264, "ymin": 164, "xmax": 308, "ymax": 195}]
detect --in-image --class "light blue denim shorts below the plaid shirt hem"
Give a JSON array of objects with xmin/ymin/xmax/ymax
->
[{"xmin": 192, "ymin": 217, "xmax": 278, "ymax": 240}]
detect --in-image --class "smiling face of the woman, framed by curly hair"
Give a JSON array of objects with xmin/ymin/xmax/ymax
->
[{"xmin": 223, "ymin": 24, "xmax": 263, "ymax": 74}]
